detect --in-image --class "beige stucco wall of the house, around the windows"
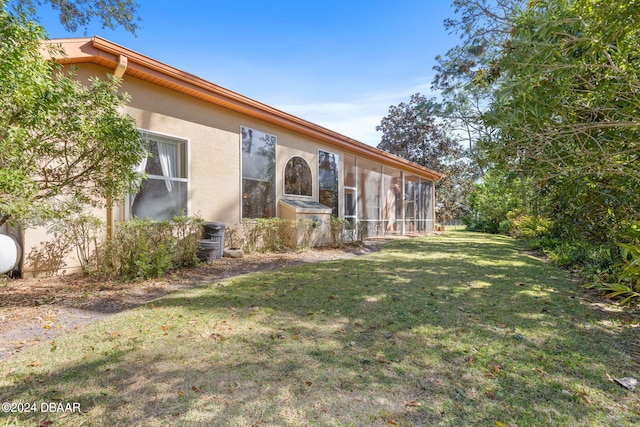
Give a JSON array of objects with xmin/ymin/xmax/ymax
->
[{"xmin": 23, "ymin": 64, "xmax": 436, "ymax": 275}]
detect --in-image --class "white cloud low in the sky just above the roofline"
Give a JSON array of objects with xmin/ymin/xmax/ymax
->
[{"xmin": 275, "ymin": 84, "xmax": 434, "ymax": 147}]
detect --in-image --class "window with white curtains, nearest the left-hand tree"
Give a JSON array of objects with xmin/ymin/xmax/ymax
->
[{"xmin": 130, "ymin": 131, "xmax": 189, "ymax": 219}]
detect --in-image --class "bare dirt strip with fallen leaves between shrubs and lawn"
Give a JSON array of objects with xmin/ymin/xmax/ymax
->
[{"xmin": 0, "ymin": 240, "xmax": 384, "ymax": 362}]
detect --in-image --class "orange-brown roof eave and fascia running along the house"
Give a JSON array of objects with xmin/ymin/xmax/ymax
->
[{"xmin": 49, "ymin": 36, "xmax": 444, "ymax": 181}]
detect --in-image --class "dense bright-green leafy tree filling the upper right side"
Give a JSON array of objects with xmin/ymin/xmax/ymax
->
[{"xmin": 478, "ymin": 0, "xmax": 640, "ymax": 241}]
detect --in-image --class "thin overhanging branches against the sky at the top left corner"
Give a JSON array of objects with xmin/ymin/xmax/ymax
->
[{"xmin": 3, "ymin": 0, "xmax": 140, "ymax": 34}]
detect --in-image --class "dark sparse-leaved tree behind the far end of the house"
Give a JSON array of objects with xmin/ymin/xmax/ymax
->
[{"xmin": 376, "ymin": 94, "xmax": 475, "ymax": 221}]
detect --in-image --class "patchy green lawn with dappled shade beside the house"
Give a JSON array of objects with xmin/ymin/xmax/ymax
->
[{"xmin": 0, "ymin": 231, "xmax": 640, "ymax": 426}]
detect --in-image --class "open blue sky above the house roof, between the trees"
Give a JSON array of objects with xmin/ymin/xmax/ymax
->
[{"xmin": 33, "ymin": 0, "xmax": 457, "ymax": 146}]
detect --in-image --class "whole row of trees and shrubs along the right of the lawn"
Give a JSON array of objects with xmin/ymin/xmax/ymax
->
[{"xmin": 378, "ymin": 0, "xmax": 640, "ymax": 298}]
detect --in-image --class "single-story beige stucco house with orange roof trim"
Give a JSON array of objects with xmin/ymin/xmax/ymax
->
[{"xmin": 5, "ymin": 37, "xmax": 442, "ymax": 275}]
